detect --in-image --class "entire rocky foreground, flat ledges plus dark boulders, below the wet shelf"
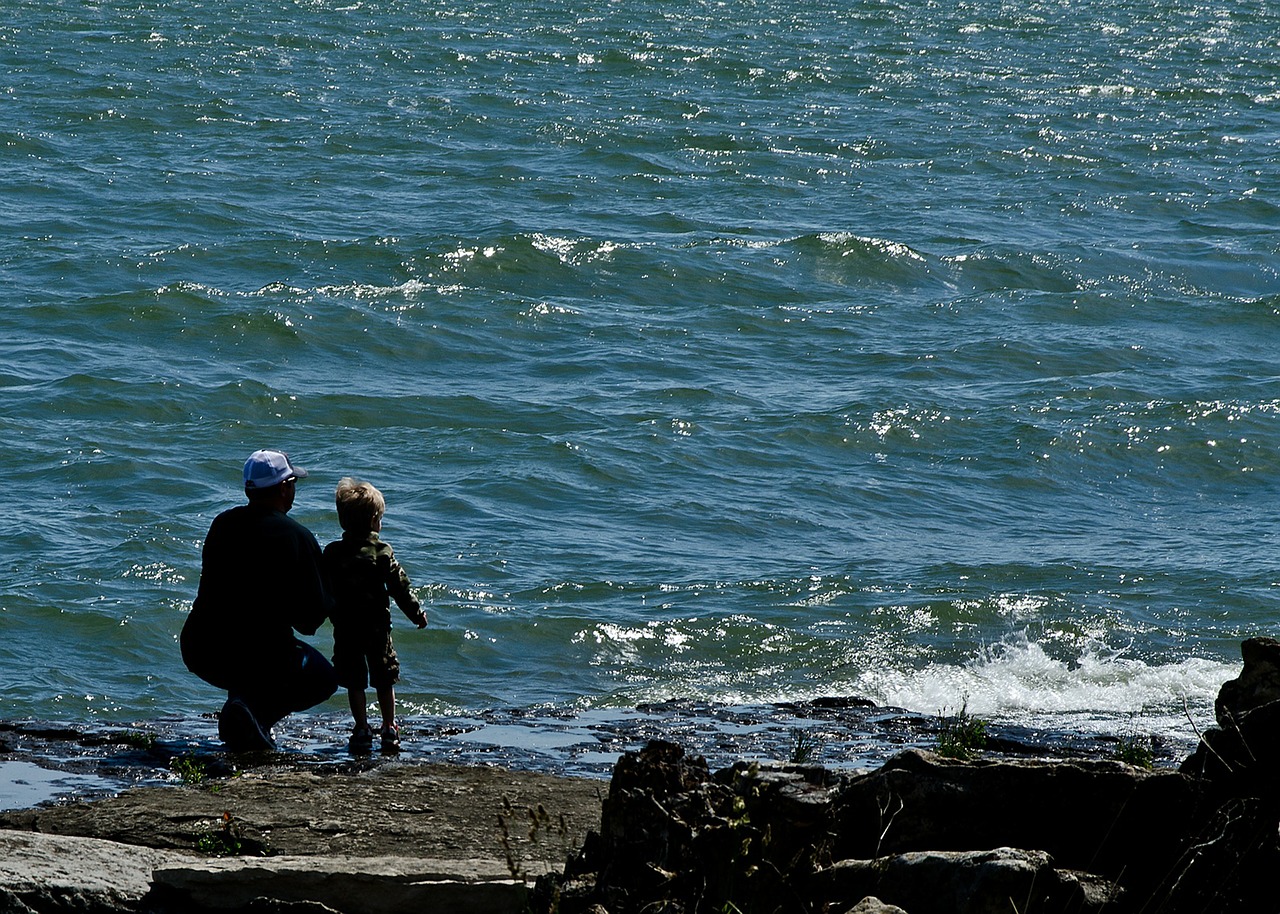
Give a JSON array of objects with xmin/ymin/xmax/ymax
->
[{"xmin": 0, "ymin": 639, "xmax": 1280, "ymax": 914}]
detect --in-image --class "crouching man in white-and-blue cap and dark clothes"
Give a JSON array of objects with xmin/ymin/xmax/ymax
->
[{"xmin": 180, "ymin": 449, "xmax": 338, "ymax": 751}]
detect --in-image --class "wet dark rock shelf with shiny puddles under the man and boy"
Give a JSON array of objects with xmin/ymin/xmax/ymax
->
[{"xmin": 0, "ymin": 698, "xmax": 1196, "ymax": 809}]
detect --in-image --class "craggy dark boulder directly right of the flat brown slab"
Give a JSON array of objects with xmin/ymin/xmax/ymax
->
[{"xmin": 543, "ymin": 741, "xmax": 840, "ymax": 914}]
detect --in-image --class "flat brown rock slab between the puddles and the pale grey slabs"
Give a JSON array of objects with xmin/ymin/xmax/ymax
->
[{"xmin": 0, "ymin": 764, "xmax": 605, "ymax": 872}]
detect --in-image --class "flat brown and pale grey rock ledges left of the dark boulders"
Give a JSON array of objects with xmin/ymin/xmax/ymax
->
[{"xmin": 0, "ymin": 764, "xmax": 605, "ymax": 914}]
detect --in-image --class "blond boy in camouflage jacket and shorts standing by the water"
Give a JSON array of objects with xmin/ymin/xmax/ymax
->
[{"xmin": 324, "ymin": 476, "xmax": 426, "ymax": 753}]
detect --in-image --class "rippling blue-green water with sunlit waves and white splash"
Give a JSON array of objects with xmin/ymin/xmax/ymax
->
[{"xmin": 0, "ymin": 0, "xmax": 1280, "ymax": 757}]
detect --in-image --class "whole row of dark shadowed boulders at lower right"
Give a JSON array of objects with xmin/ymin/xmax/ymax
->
[{"xmin": 534, "ymin": 637, "xmax": 1280, "ymax": 914}]
